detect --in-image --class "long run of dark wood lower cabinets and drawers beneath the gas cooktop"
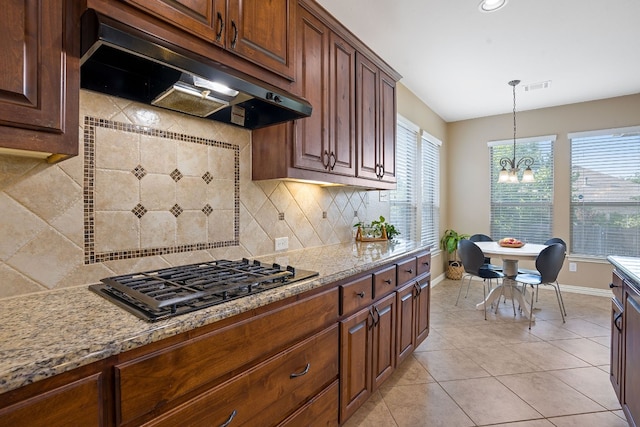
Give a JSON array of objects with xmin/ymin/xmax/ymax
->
[{"xmin": 0, "ymin": 251, "xmax": 432, "ymax": 427}]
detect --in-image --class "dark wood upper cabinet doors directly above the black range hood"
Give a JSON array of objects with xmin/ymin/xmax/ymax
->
[{"xmin": 122, "ymin": 0, "xmax": 295, "ymax": 80}]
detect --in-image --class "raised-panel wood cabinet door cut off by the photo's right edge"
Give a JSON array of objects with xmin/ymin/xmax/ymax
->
[{"xmin": 622, "ymin": 283, "xmax": 640, "ymax": 425}]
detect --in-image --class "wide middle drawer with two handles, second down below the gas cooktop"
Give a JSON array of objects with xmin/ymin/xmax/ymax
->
[{"xmin": 146, "ymin": 323, "xmax": 338, "ymax": 427}]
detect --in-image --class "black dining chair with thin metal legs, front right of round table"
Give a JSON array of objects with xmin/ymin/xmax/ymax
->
[{"xmin": 514, "ymin": 243, "xmax": 567, "ymax": 329}]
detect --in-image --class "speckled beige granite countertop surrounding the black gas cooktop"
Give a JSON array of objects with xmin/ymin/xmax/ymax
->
[{"xmin": 0, "ymin": 241, "xmax": 425, "ymax": 393}]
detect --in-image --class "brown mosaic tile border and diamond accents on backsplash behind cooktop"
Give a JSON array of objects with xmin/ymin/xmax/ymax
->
[{"xmin": 83, "ymin": 116, "xmax": 240, "ymax": 264}]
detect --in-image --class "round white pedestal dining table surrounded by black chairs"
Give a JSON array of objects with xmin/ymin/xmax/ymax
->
[{"xmin": 476, "ymin": 242, "xmax": 547, "ymax": 320}]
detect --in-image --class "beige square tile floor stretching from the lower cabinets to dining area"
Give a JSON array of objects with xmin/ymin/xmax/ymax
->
[{"xmin": 345, "ymin": 280, "xmax": 627, "ymax": 427}]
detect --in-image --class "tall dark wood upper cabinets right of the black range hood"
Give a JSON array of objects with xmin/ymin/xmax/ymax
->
[{"xmin": 252, "ymin": 0, "xmax": 400, "ymax": 189}]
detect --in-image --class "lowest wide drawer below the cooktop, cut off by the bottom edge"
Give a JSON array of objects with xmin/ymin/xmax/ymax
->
[{"xmin": 278, "ymin": 381, "xmax": 338, "ymax": 427}]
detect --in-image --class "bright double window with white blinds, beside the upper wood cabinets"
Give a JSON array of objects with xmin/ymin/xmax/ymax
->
[{"xmin": 389, "ymin": 117, "xmax": 441, "ymax": 250}]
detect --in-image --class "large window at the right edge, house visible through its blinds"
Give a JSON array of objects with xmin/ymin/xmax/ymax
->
[{"xmin": 569, "ymin": 126, "xmax": 640, "ymax": 257}]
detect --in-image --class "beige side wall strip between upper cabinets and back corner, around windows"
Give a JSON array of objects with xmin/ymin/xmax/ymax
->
[{"xmin": 397, "ymin": 83, "xmax": 449, "ymax": 278}]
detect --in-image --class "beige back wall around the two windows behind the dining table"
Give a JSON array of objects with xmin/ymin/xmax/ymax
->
[{"xmin": 443, "ymin": 94, "xmax": 640, "ymax": 288}]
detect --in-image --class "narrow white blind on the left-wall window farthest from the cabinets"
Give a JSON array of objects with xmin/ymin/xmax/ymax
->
[{"xmin": 420, "ymin": 132, "xmax": 442, "ymax": 250}]
